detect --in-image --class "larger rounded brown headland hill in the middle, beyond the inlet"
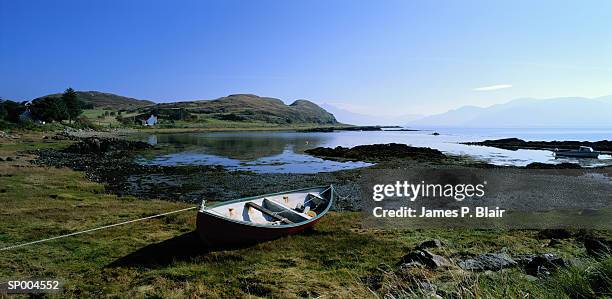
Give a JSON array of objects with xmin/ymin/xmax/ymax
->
[{"xmin": 143, "ymin": 94, "xmax": 338, "ymax": 124}]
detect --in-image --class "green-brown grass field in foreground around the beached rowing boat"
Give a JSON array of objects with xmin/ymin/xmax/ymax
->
[{"xmin": 0, "ymin": 133, "xmax": 612, "ymax": 298}]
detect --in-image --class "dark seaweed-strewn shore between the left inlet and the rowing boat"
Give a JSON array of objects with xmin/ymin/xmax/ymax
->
[{"xmin": 31, "ymin": 137, "xmax": 366, "ymax": 210}]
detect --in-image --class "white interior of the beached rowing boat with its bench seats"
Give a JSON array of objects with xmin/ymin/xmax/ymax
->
[{"xmin": 204, "ymin": 188, "xmax": 331, "ymax": 225}]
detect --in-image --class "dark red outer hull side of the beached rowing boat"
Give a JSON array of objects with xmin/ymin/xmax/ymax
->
[{"xmin": 196, "ymin": 212, "xmax": 320, "ymax": 246}]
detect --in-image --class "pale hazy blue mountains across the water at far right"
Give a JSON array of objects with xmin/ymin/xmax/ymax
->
[{"xmin": 408, "ymin": 96, "xmax": 612, "ymax": 128}]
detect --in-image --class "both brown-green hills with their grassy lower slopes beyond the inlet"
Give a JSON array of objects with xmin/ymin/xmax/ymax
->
[{"xmin": 33, "ymin": 91, "xmax": 341, "ymax": 128}]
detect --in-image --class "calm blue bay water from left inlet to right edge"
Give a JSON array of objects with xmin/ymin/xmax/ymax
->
[{"xmin": 138, "ymin": 129, "xmax": 612, "ymax": 173}]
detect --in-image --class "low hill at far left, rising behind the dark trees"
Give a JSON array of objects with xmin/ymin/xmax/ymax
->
[{"xmin": 35, "ymin": 91, "xmax": 155, "ymax": 109}]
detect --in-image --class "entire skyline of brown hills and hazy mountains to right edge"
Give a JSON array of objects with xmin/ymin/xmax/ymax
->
[{"xmin": 31, "ymin": 91, "xmax": 612, "ymax": 128}]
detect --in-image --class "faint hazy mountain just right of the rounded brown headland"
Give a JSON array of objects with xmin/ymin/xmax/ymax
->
[{"xmin": 321, "ymin": 104, "xmax": 423, "ymax": 126}]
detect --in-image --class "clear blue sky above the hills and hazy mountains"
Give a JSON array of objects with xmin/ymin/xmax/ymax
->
[{"xmin": 0, "ymin": 0, "xmax": 612, "ymax": 114}]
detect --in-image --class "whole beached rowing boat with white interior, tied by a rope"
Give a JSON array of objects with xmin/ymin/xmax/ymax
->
[{"xmin": 197, "ymin": 185, "xmax": 335, "ymax": 245}]
